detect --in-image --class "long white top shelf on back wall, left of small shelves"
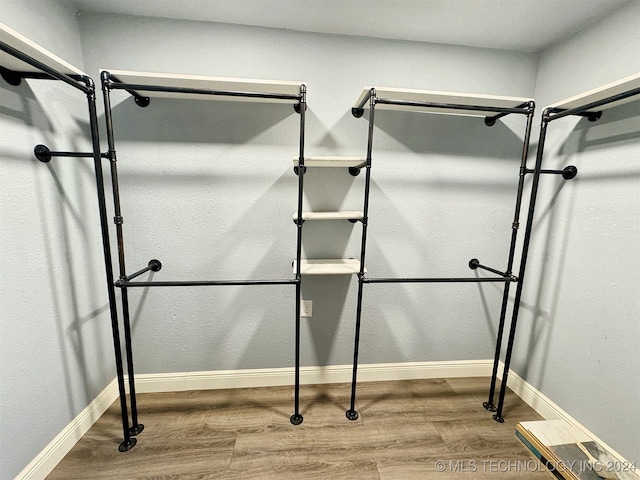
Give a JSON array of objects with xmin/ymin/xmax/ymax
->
[{"xmin": 101, "ymin": 69, "xmax": 305, "ymax": 104}]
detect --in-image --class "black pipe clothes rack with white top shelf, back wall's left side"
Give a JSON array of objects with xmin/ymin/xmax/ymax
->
[{"xmin": 100, "ymin": 70, "xmax": 307, "ymax": 450}]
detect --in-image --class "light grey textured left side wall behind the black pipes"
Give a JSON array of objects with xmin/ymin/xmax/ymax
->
[{"xmin": 0, "ymin": 1, "xmax": 115, "ymax": 478}]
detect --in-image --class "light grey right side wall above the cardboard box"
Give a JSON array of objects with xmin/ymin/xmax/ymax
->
[{"xmin": 512, "ymin": 2, "xmax": 640, "ymax": 462}]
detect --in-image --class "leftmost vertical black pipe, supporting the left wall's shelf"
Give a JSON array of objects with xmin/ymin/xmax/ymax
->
[{"xmin": 86, "ymin": 77, "xmax": 136, "ymax": 452}]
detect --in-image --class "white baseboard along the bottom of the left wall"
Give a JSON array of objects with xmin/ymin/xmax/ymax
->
[{"xmin": 15, "ymin": 379, "xmax": 118, "ymax": 480}]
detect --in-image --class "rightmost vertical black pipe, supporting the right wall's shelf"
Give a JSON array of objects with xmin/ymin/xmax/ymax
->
[{"xmin": 493, "ymin": 110, "xmax": 549, "ymax": 423}]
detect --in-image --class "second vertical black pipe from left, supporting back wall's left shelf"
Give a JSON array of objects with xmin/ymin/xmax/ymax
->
[{"xmin": 102, "ymin": 72, "xmax": 144, "ymax": 435}]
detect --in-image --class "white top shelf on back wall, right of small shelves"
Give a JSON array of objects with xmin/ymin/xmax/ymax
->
[{"xmin": 354, "ymin": 87, "xmax": 532, "ymax": 117}]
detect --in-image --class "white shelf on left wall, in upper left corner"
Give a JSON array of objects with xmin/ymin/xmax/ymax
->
[{"xmin": 0, "ymin": 23, "xmax": 87, "ymax": 76}]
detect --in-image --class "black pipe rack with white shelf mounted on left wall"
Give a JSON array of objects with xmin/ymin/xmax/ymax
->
[{"xmin": 0, "ymin": 23, "xmax": 136, "ymax": 451}]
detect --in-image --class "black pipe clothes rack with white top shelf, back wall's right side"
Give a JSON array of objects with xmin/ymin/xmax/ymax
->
[{"xmin": 346, "ymin": 87, "xmax": 540, "ymax": 422}]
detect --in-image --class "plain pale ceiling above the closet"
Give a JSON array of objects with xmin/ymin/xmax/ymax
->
[{"xmin": 69, "ymin": 0, "xmax": 640, "ymax": 52}]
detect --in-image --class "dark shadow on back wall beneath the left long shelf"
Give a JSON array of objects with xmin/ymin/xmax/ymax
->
[{"xmin": 99, "ymin": 97, "xmax": 298, "ymax": 144}]
